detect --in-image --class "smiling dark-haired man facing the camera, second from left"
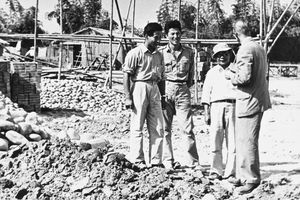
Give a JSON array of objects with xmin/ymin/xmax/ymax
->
[{"xmin": 159, "ymin": 20, "xmax": 199, "ymax": 169}]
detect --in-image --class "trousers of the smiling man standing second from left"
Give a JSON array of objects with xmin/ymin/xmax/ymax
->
[{"xmin": 163, "ymin": 82, "xmax": 199, "ymax": 166}]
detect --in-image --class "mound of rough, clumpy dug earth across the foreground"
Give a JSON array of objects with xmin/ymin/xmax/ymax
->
[{"xmin": 0, "ymin": 138, "xmax": 230, "ymax": 200}]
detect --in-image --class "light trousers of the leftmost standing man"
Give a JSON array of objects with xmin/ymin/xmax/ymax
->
[{"xmin": 128, "ymin": 82, "xmax": 164, "ymax": 164}]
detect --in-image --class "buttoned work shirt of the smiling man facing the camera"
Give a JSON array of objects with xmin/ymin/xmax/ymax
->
[{"xmin": 159, "ymin": 45, "xmax": 194, "ymax": 82}]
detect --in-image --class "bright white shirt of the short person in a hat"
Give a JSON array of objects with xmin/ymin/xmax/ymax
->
[{"xmin": 201, "ymin": 65, "xmax": 237, "ymax": 104}]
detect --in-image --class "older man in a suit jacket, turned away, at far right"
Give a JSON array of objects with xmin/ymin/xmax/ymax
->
[{"xmin": 225, "ymin": 20, "xmax": 271, "ymax": 194}]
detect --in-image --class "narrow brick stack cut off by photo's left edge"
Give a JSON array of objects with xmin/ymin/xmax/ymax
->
[{"xmin": 0, "ymin": 61, "xmax": 11, "ymax": 98}]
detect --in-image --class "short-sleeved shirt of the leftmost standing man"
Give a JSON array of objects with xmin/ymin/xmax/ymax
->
[{"xmin": 123, "ymin": 44, "xmax": 164, "ymax": 81}]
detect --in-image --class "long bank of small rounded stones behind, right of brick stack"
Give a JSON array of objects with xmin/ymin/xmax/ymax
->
[{"xmin": 41, "ymin": 79, "xmax": 124, "ymax": 113}]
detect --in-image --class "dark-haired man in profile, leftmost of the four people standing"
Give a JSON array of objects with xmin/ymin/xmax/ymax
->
[{"xmin": 123, "ymin": 23, "xmax": 164, "ymax": 170}]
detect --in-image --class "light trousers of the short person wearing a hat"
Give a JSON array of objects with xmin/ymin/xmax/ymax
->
[{"xmin": 210, "ymin": 102, "xmax": 236, "ymax": 178}]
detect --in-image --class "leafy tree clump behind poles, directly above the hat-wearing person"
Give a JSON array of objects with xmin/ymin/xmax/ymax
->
[{"xmin": 157, "ymin": 0, "xmax": 232, "ymax": 38}]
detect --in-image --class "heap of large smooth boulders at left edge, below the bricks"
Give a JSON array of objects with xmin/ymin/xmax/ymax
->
[{"xmin": 0, "ymin": 93, "xmax": 49, "ymax": 151}]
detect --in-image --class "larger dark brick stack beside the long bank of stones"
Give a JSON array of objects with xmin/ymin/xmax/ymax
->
[{"xmin": 10, "ymin": 62, "xmax": 42, "ymax": 112}]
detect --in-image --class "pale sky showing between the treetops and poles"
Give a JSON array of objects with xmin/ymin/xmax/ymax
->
[{"xmin": 4, "ymin": 0, "xmax": 288, "ymax": 33}]
